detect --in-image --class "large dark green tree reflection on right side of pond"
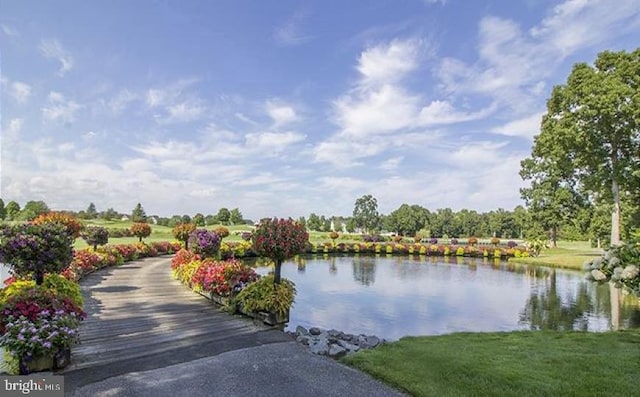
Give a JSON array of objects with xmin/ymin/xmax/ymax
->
[{"xmin": 520, "ymin": 270, "xmax": 593, "ymax": 331}]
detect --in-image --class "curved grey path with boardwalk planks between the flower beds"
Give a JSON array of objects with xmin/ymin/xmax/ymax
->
[{"xmin": 61, "ymin": 257, "xmax": 401, "ymax": 397}]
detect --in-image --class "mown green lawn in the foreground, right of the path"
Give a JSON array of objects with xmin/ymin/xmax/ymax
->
[{"xmin": 342, "ymin": 331, "xmax": 640, "ymax": 397}]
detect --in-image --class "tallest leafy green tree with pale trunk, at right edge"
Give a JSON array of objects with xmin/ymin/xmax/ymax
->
[{"xmin": 534, "ymin": 49, "xmax": 640, "ymax": 245}]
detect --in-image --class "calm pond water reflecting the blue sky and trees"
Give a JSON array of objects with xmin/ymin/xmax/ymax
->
[{"xmin": 252, "ymin": 256, "xmax": 640, "ymax": 340}]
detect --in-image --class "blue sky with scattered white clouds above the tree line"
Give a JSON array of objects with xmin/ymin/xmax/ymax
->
[{"xmin": 0, "ymin": 0, "xmax": 640, "ymax": 219}]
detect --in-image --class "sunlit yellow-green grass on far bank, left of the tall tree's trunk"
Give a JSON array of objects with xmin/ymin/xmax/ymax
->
[{"xmin": 509, "ymin": 241, "xmax": 602, "ymax": 270}]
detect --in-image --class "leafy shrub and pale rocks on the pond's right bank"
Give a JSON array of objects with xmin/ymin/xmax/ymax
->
[{"xmin": 584, "ymin": 244, "xmax": 640, "ymax": 297}]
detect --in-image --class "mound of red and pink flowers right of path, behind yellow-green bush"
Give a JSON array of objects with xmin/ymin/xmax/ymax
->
[{"xmin": 191, "ymin": 260, "xmax": 258, "ymax": 296}]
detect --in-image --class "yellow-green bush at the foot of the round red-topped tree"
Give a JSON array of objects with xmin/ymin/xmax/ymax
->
[{"xmin": 235, "ymin": 275, "xmax": 296, "ymax": 315}]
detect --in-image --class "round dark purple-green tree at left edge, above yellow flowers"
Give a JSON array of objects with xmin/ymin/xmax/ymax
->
[{"xmin": 0, "ymin": 223, "xmax": 74, "ymax": 285}]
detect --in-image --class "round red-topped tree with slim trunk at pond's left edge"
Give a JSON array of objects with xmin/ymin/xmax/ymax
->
[{"xmin": 252, "ymin": 218, "xmax": 309, "ymax": 284}]
